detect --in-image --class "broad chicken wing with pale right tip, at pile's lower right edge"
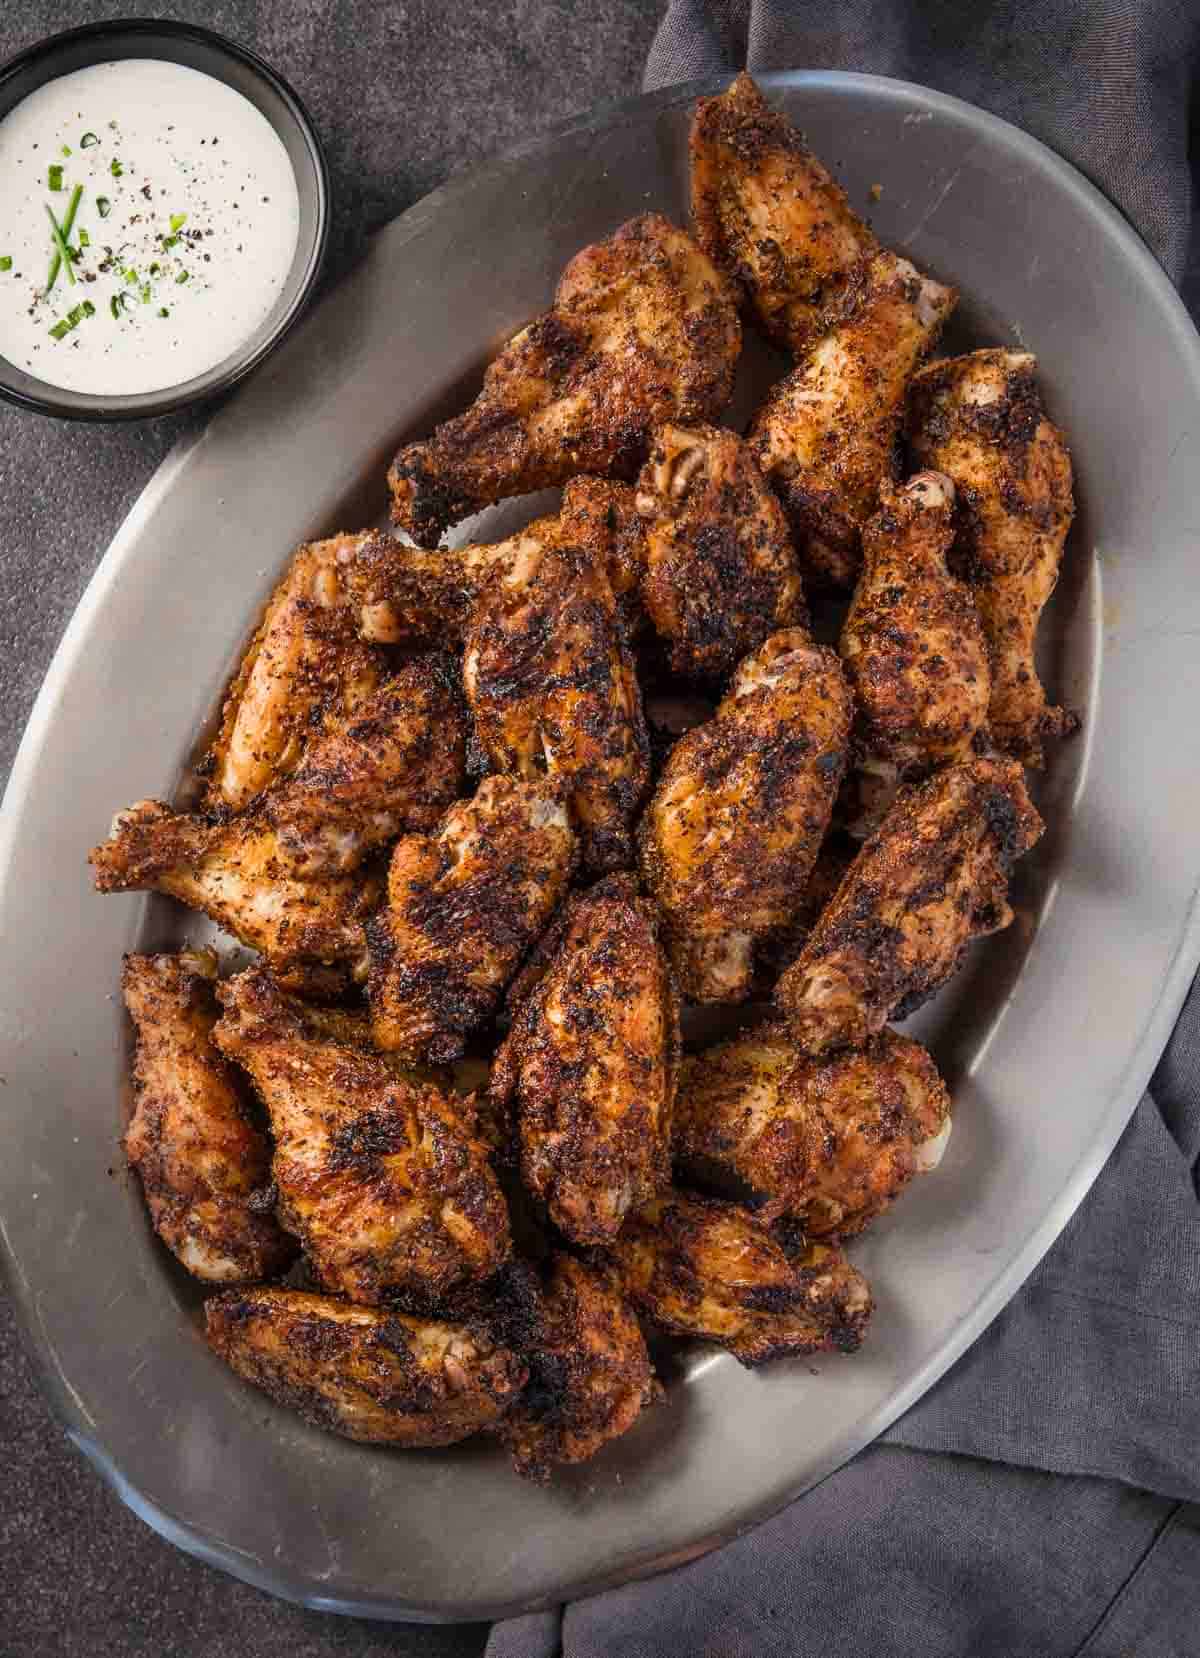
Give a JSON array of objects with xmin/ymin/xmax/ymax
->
[{"xmin": 675, "ymin": 1025, "xmax": 950, "ymax": 1239}]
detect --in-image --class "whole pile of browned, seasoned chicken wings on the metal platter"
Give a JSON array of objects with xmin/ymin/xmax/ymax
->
[{"xmin": 91, "ymin": 75, "xmax": 1072, "ymax": 1477}]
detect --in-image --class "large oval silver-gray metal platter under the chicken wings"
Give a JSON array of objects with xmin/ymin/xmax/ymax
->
[{"xmin": 0, "ymin": 73, "xmax": 1200, "ymax": 1620}]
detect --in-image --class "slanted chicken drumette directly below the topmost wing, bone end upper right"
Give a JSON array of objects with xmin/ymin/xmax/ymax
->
[{"xmin": 749, "ymin": 252, "xmax": 958, "ymax": 587}]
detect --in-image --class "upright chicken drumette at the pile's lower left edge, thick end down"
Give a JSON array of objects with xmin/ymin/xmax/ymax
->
[{"xmin": 121, "ymin": 952, "xmax": 295, "ymax": 1283}]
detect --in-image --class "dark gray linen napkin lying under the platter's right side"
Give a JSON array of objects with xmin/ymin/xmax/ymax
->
[{"xmin": 487, "ymin": 0, "xmax": 1200, "ymax": 1658}]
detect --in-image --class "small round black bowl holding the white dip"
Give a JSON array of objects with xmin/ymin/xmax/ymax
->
[{"xmin": 0, "ymin": 18, "xmax": 330, "ymax": 421}]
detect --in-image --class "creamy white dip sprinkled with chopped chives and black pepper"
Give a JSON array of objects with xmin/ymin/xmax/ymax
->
[{"xmin": 0, "ymin": 58, "xmax": 300, "ymax": 396}]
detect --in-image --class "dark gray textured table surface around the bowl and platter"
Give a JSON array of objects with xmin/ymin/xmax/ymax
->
[{"xmin": 0, "ymin": 0, "xmax": 663, "ymax": 1658}]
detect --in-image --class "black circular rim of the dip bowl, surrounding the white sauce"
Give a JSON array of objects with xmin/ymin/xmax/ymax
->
[{"xmin": 0, "ymin": 17, "xmax": 331, "ymax": 424}]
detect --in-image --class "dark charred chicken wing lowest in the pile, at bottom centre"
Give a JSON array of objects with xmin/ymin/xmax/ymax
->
[{"xmin": 501, "ymin": 1252, "xmax": 655, "ymax": 1481}]
